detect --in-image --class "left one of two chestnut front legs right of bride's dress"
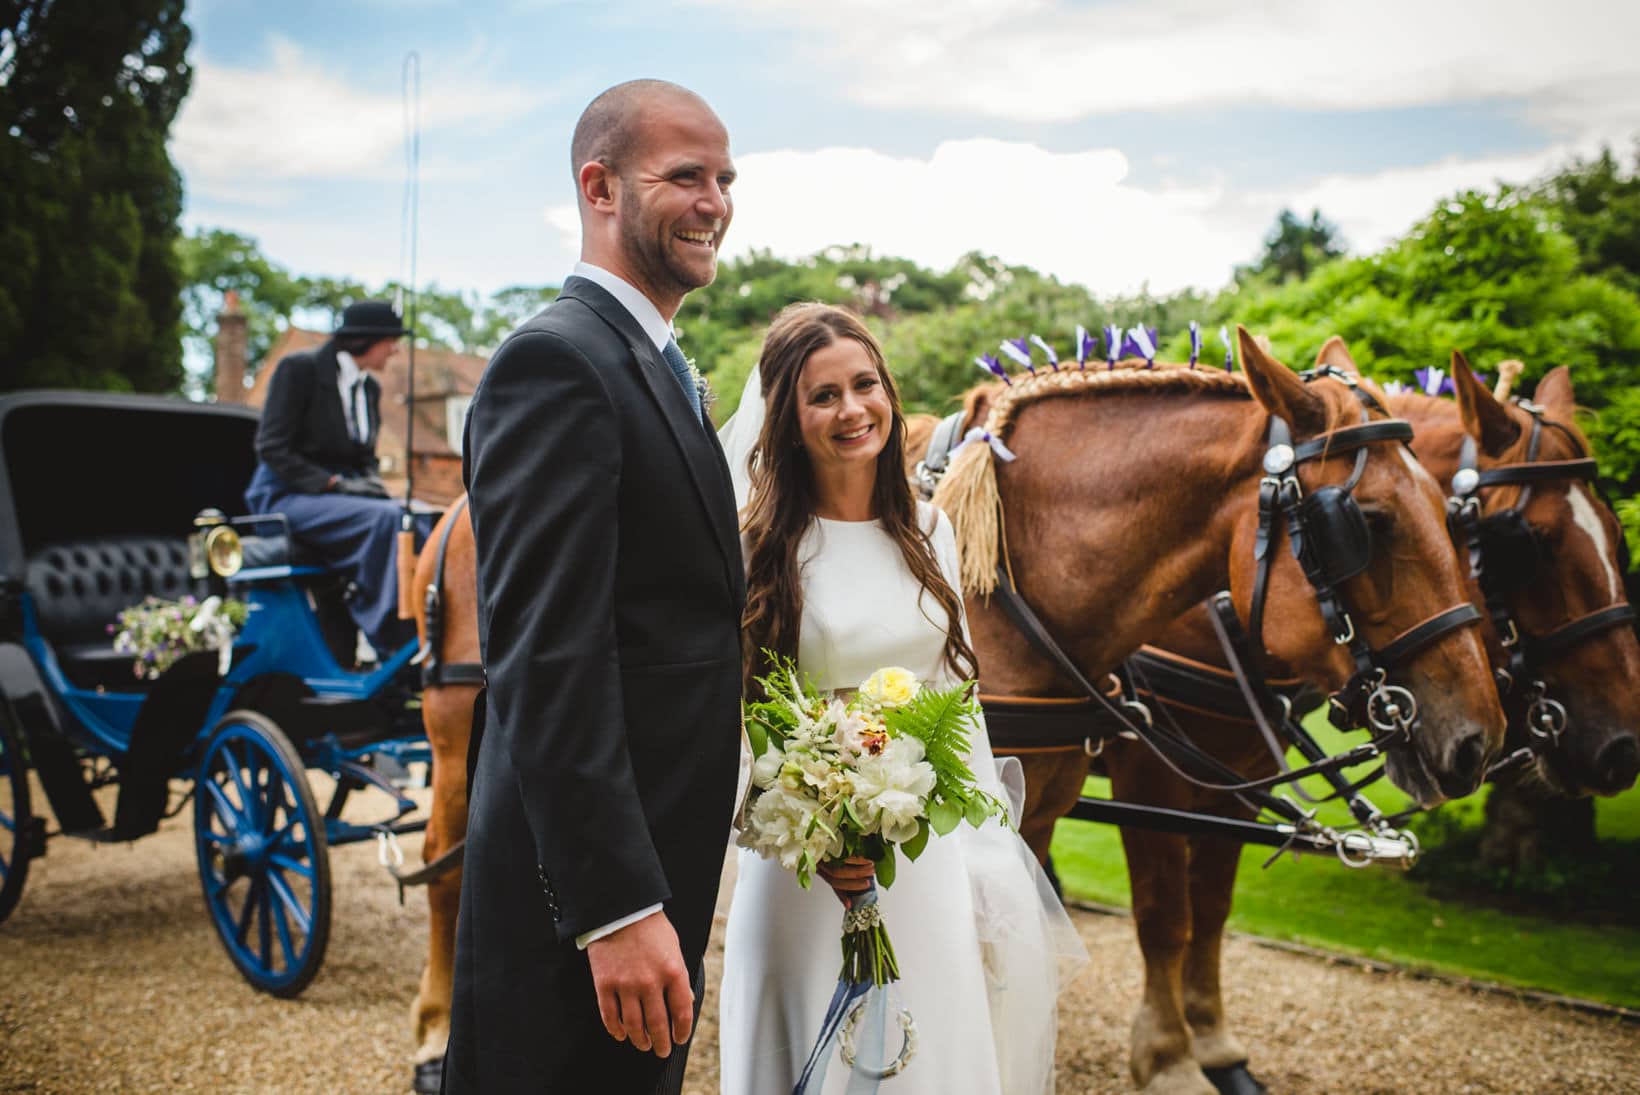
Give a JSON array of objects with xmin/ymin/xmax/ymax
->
[{"xmin": 1104, "ymin": 743, "xmax": 1215, "ymax": 1095}]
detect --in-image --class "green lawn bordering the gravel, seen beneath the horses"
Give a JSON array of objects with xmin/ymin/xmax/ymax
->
[{"xmin": 1053, "ymin": 720, "xmax": 1640, "ymax": 1008}]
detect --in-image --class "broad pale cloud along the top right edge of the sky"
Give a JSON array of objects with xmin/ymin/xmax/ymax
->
[{"xmin": 697, "ymin": 0, "xmax": 1640, "ymax": 138}]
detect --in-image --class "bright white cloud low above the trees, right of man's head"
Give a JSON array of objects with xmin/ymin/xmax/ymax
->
[{"xmin": 544, "ymin": 139, "xmax": 1594, "ymax": 295}]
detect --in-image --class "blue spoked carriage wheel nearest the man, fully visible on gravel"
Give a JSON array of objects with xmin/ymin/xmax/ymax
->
[{"xmin": 194, "ymin": 711, "xmax": 330, "ymax": 997}]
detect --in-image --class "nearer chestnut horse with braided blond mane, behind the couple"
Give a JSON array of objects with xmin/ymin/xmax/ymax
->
[{"xmin": 403, "ymin": 333, "xmax": 1504, "ymax": 1081}]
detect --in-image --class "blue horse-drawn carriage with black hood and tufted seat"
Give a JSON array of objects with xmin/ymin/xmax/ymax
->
[{"xmin": 0, "ymin": 392, "xmax": 430, "ymax": 997}]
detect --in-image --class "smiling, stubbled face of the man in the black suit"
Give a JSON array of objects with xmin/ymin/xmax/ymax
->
[{"xmin": 620, "ymin": 97, "xmax": 735, "ymax": 311}]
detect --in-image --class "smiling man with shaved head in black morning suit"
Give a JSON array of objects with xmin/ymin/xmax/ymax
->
[{"xmin": 444, "ymin": 80, "xmax": 745, "ymax": 1095}]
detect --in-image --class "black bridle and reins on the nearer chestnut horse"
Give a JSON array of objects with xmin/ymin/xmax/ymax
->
[{"xmin": 917, "ymin": 369, "xmax": 1481, "ymax": 866}]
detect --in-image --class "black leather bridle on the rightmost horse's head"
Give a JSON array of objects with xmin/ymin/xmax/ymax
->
[{"xmin": 1446, "ymin": 398, "xmax": 1635, "ymax": 760}]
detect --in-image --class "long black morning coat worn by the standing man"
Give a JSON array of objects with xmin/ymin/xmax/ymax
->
[{"xmin": 444, "ymin": 277, "xmax": 745, "ymax": 1095}]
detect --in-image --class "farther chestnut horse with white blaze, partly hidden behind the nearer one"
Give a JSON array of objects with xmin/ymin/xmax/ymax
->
[{"xmin": 944, "ymin": 339, "xmax": 1640, "ymax": 1093}]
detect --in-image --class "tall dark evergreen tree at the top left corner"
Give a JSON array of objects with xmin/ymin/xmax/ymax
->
[{"xmin": 0, "ymin": 0, "xmax": 192, "ymax": 392}]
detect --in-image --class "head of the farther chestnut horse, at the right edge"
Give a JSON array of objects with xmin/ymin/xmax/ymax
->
[{"xmin": 1448, "ymin": 351, "xmax": 1640, "ymax": 795}]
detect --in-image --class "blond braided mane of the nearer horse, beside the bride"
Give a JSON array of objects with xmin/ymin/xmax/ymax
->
[{"xmin": 933, "ymin": 359, "xmax": 1251, "ymax": 593}]
